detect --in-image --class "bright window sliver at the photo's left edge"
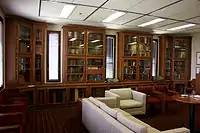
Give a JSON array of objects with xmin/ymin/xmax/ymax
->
[{"xmin": 0, "ymin": 17, "xmax": 3, "ymax": 86}]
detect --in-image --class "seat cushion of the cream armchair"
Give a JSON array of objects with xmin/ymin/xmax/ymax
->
[{"xmin": 120, "ymin": 99, "xmax": 143, "ymax": 109}]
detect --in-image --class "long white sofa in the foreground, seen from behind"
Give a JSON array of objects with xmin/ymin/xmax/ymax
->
[{"xmin": 82, "ymin": 97, "xmax": 190, "ymax": 133}]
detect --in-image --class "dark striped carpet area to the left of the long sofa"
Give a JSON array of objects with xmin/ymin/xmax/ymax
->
[{"xmin": 26, "ymin": 105, "xmax": 87, "ymax": 133}]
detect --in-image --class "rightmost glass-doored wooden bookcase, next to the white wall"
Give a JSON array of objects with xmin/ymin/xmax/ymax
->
[{"xmin": 160, "ymin": 36, "xmax": 191, "ymax": 91}]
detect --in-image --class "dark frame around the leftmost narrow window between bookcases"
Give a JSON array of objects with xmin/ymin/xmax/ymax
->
[{"xmin": 46, "ymin": 30, "xmax": 61, "ymax": 82}]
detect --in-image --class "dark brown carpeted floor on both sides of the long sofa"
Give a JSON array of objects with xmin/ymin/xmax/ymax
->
[{"xmin": 26, "ymin": 104, "xmax": 200, "ymax": 133}]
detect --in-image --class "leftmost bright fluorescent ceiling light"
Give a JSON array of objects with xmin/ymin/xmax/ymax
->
[{"xmin": 60, "ymin": 5, "xmax": 76, "ymax": 18}]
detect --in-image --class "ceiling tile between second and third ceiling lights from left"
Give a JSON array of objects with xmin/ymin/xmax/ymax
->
[{"xmin": 110, "ymin": 13, "xmax": 141, "ymax": 24}]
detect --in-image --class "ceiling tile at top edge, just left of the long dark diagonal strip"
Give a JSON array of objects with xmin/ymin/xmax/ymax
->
[{"xmin": 73, "ymin": 0, "xmax": 106, "ymax": 6}]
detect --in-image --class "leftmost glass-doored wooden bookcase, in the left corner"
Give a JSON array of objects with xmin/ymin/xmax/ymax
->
[{"xmin": 5, "ymin": 17, "xmax": 46, "ymax": 84}]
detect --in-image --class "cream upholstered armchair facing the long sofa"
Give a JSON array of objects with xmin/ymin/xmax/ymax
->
[{"xmin": 105, "ymin": 88, "xmax": 146, "ymax": 115}]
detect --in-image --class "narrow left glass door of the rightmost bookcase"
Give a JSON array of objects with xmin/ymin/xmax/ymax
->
[{"xmin": 165, "ymin": 41, "xmax": 172, "ymax": 80}]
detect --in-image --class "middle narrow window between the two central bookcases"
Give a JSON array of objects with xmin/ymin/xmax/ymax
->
[{"xmin": 106, "ymin": 35, "xmax": 116, "ymax": 78}]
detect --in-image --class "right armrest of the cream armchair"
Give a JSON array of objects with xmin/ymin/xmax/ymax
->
[{"xmin": 132, "ymin": 90, "xmax": 146, "ymax": 105}]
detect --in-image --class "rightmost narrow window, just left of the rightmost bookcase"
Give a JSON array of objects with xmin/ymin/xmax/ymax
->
[{"xmin": 152, "ymin": 39, "xmax": 158, "ymax": 76}]
